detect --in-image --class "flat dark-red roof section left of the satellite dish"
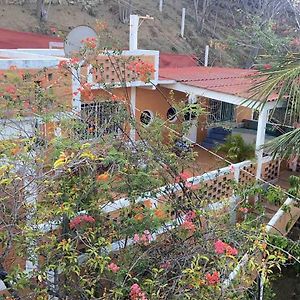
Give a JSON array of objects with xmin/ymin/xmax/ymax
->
[{"xmin": 0, "ymin": 28, "xmax": 62, "ymax": 49}]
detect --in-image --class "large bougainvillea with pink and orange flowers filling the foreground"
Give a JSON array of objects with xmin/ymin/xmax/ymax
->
[{"xmin": 0, "ymin": 23, "xmax": 296, "ymax": 300}]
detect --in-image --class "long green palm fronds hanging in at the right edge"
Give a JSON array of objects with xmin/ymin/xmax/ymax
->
[{"xmin": 252, "ymin": 53, "xmax": 300, "ymax": 157}]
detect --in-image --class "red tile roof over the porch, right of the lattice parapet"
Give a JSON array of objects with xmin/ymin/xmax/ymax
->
[{"xmin": 159, "ymin": 67, "xmax": 276, "ymax": 100}]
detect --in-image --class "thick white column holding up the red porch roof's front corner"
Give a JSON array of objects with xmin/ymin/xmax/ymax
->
[{"xmin": 255, "ymin": 106, "xmax": 269, "ymax": 179}]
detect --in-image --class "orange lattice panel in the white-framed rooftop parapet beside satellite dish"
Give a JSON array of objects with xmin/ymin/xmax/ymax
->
[{"xmin": 92, "ymin": 56, "xmax": 155, "ymax": 83}]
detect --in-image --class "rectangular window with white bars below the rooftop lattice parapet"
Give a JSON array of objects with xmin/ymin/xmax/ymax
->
[{"xmin": 81, "ymin": 101, "xmax": 125, "ymax": 139}]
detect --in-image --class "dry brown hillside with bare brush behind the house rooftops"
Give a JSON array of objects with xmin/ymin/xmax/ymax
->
[{"xmin": 0, "ymin": 0, "xmax": 297, "ymax": 66}]
